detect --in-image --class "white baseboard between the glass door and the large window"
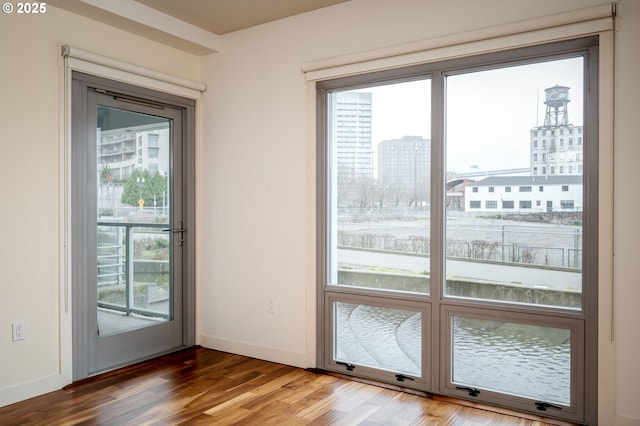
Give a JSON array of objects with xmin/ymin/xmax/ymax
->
[{"xmin": 198, "ymin": 334, "xmax": 311, "ymax": 368}]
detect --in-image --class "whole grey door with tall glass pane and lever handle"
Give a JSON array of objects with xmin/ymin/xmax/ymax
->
[{"xmin": 74, "ymin": 73, "xmax": 192, "ymax": 379}]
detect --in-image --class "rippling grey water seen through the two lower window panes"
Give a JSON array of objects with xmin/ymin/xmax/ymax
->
[{"xmin": 334, "ymin": 302, "xmax": 571, "ymax": 405}]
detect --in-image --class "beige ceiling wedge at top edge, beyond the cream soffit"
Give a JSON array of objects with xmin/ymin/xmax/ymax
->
[{"xmin": 135, "ymin": 0, "xmax": 348, "ymax": 35}]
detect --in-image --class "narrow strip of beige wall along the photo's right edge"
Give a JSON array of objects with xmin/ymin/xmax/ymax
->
[{"xmin": 613, "ymin": 0, "xmax": 640, "ymax": 426}]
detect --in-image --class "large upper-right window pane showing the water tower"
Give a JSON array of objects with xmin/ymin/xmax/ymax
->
[{"xmin": 444, "ymin": 57, "xmax": 585, "ymax": 309}]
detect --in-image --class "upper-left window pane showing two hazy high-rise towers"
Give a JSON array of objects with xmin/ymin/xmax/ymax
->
[{"xmin": 328, "ymin": 80, "xmax": 431, "ymax": 294}]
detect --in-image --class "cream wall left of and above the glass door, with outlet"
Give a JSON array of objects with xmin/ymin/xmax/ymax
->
[{"xmin": 0, "ymin": 5, "xmax": 200, "ymax": 406}]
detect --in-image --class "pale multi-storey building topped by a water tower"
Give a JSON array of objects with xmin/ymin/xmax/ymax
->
[{"xmin": 531, "ymin": 85, "xmax": 583, "ymax": 176}]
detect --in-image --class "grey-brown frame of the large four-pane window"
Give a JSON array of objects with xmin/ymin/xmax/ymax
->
[{"xmin": 316, "ymin": 36, "xmax": 599, "ymax": 423}]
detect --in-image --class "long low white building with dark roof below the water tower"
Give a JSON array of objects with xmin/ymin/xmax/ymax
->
[{"xmin": 464, "ymin": 176, "xmax": 582, "ymax": 213}]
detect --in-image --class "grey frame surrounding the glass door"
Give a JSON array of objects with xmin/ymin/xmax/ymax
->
[{"xmin": 69, "ymin": 71, "xmax": 196, "ymax": 381}]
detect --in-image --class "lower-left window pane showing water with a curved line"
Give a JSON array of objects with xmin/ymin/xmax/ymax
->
[{"xmin": 333, "ymin": 302, "xmax": 422, "ymax": 377}]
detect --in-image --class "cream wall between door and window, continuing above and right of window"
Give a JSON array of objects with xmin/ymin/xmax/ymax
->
[{"xmin": 198, "ymin": 0, "xmax": 640, "ymax": 424}]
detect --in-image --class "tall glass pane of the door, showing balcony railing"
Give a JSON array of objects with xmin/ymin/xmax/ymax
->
[{"xmin": 96, "ymin": 106, "xmax": 172, "ymax": 335}]
